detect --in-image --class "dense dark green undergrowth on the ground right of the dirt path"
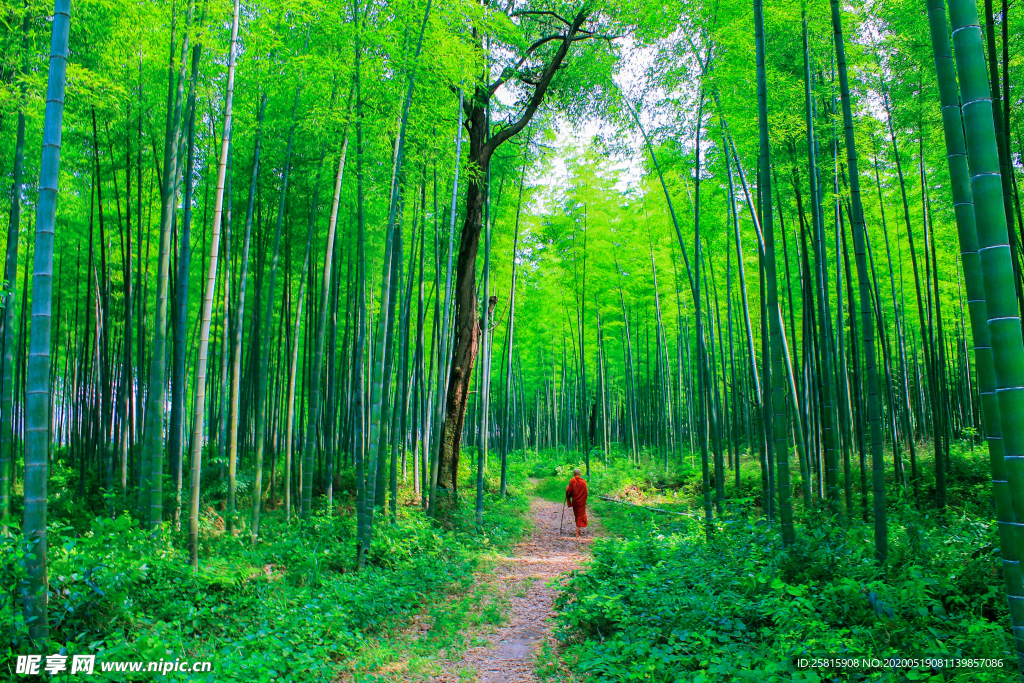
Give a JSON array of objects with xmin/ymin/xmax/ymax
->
[{"xmin": 532, "ymin": 449, "xmax": 1016, "ymax": 682}]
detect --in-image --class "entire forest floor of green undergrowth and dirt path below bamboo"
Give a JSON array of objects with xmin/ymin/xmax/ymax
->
[{"xmin": 0, "ymin": 444, "xmax": 1013, "ymax": 683}]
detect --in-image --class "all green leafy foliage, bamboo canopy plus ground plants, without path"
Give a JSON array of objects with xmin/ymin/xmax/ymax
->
[{"xmin": 0, "ymin": 0, "xmax": 1024, "ymax": 680}]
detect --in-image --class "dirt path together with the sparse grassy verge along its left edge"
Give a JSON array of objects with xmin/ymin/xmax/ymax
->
[{"xmin": 339, "ymin": 478, "xmax": 605, "ymax": 683}]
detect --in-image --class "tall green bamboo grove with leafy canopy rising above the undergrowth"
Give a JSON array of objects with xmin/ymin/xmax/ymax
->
[{"xmin": 0, "ymin": 0, "xmax": 1024, "ymax": 663}]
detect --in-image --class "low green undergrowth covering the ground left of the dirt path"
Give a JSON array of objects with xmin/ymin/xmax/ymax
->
[{"xmin": 6, "ymin": 450, "xmax": 529, "ymax": 683}]
